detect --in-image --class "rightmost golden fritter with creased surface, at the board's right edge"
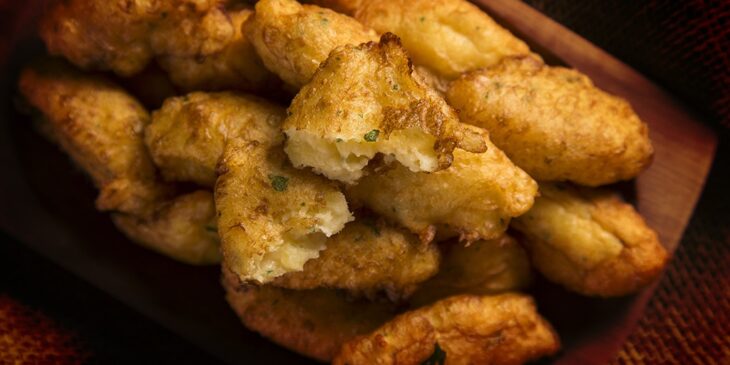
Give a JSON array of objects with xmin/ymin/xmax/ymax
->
[{"xmin": 513, "ymin": 184, "xmax": 668, "ymax": 297}]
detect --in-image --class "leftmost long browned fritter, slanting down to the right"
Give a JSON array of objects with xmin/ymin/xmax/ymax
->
[{"xmin": 19, "ymin": 60, "xmax": 167, "ymax": 215}]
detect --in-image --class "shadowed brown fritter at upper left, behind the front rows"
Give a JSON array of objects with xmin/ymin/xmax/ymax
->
[{"xmin": 158, "ymin": 7, "xmax": 281, "ymax": 91}]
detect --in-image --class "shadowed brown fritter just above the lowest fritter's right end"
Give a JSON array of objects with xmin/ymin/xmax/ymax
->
[{"xmin": 409, "ymin": 235, "xmax": 530, "ymax": 307}]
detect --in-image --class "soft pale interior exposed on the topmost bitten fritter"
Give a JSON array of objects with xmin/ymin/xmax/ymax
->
[{"xmin": 284, "ymin": 129, "xmax": 438, "ymax": 184}]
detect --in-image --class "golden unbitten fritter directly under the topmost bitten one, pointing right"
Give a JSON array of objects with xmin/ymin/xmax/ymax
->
[{"xmin": 347, "ymin": 127, "xmax": 537, "ymax": 242}]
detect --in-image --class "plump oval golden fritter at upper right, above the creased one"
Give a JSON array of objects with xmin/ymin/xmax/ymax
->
[{"xmin": 448, "ymin": 57, "xmax": 653, "ymax": 186}]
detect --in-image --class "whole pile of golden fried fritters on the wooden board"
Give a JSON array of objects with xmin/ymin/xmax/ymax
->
[{"xmin": 19, "ymin": 0, "xmax": 667, "ymax": 364}]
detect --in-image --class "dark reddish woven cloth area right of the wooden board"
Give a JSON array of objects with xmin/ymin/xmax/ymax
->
[{"xmin": 526, "ymin": 0, "xmax": 730, "ymax": 365}]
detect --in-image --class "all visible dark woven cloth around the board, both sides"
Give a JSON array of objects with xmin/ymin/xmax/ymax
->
[{"xmin": 0, "ymin": 0, "xmax": 730, "ymax": 364}]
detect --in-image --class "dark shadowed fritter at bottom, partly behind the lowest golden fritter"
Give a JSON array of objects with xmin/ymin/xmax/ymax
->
[{"xmin": 223, "ymin": 267, "xmax": 395, "ymax": 362}]
